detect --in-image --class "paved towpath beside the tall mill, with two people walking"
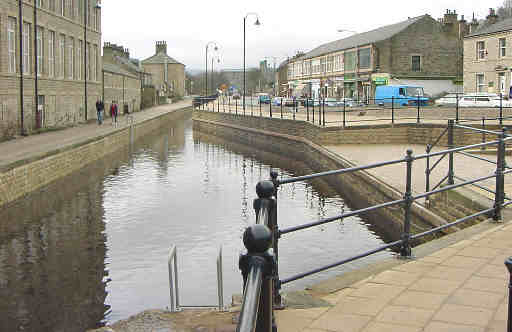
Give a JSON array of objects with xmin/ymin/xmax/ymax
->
[{"xmin": 0, "ymin": 100, "xmax": 192, "ymax": 169}]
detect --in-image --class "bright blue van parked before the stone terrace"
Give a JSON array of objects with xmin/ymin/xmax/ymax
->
[{"xmin": 375, "ymin": 85, "xmax": 428, "ymax": 106}]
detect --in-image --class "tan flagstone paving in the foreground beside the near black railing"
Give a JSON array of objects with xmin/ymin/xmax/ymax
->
[{"xmin": 277, "ymin": 219, "xmax": 512, "ymax": 332}]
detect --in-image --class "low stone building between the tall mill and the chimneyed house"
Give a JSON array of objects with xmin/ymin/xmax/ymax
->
[{"xmin": 102, "ymin": 43, "xmax": 155, "ymax": 113}]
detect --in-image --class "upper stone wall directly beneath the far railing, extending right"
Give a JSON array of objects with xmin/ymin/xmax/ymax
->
[{"xmin": 190, "ymin": 110, "xmax": 500, "ymax": 147}]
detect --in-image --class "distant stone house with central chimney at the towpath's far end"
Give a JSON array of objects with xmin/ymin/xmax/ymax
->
[{"xmin": 142, "ymin": 41, "xmax": 185, "ymax": 98}]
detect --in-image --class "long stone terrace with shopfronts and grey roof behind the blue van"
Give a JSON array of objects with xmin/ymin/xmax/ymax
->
[{"xmin": 287, "ymin": 11, "xmax": 468, "ymax": 102}]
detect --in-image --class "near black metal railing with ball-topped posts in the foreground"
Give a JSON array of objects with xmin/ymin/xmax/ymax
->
[{"xmin": 239, "ymin": 123, "xmax": 512, "ymax": 331}]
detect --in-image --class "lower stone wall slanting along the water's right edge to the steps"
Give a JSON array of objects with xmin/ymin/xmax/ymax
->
[{"xmin": 194, "ymin": 111, "xmax": 444, "ymax": 239}]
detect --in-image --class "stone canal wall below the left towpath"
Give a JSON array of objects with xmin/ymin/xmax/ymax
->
[{"xmin": 0, "ymin": 108, "xmax": 191, "ymax": 207}]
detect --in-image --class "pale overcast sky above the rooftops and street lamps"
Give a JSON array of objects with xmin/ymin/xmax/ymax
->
[{"xmin": 102, "ymin": 0, "xmax": 503, "ymax": 70}]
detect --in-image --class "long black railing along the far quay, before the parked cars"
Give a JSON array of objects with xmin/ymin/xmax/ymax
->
[{"xmin": 195, "ymin": 94, "xmax": 512, "ymax": 127}]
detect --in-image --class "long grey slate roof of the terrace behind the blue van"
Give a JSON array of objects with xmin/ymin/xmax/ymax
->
[{"xmin": 300, "ymin": 14, "xmax": 429, "ymax": 59}]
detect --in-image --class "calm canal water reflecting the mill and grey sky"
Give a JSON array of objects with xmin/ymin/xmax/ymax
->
[{"xmin": 0, "ymin": 113, "xmax": 392, "ymax": 331}]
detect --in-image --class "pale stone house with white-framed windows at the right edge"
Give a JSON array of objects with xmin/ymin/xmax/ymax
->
[{"xmin": 464, "ymin": 11, "xmax": 512, "ymax": 97}]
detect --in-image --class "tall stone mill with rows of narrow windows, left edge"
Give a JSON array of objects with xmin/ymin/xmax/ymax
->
[{"xmin": 0, "ymin": 0, "xmax": 102, "ymax": 140}]
